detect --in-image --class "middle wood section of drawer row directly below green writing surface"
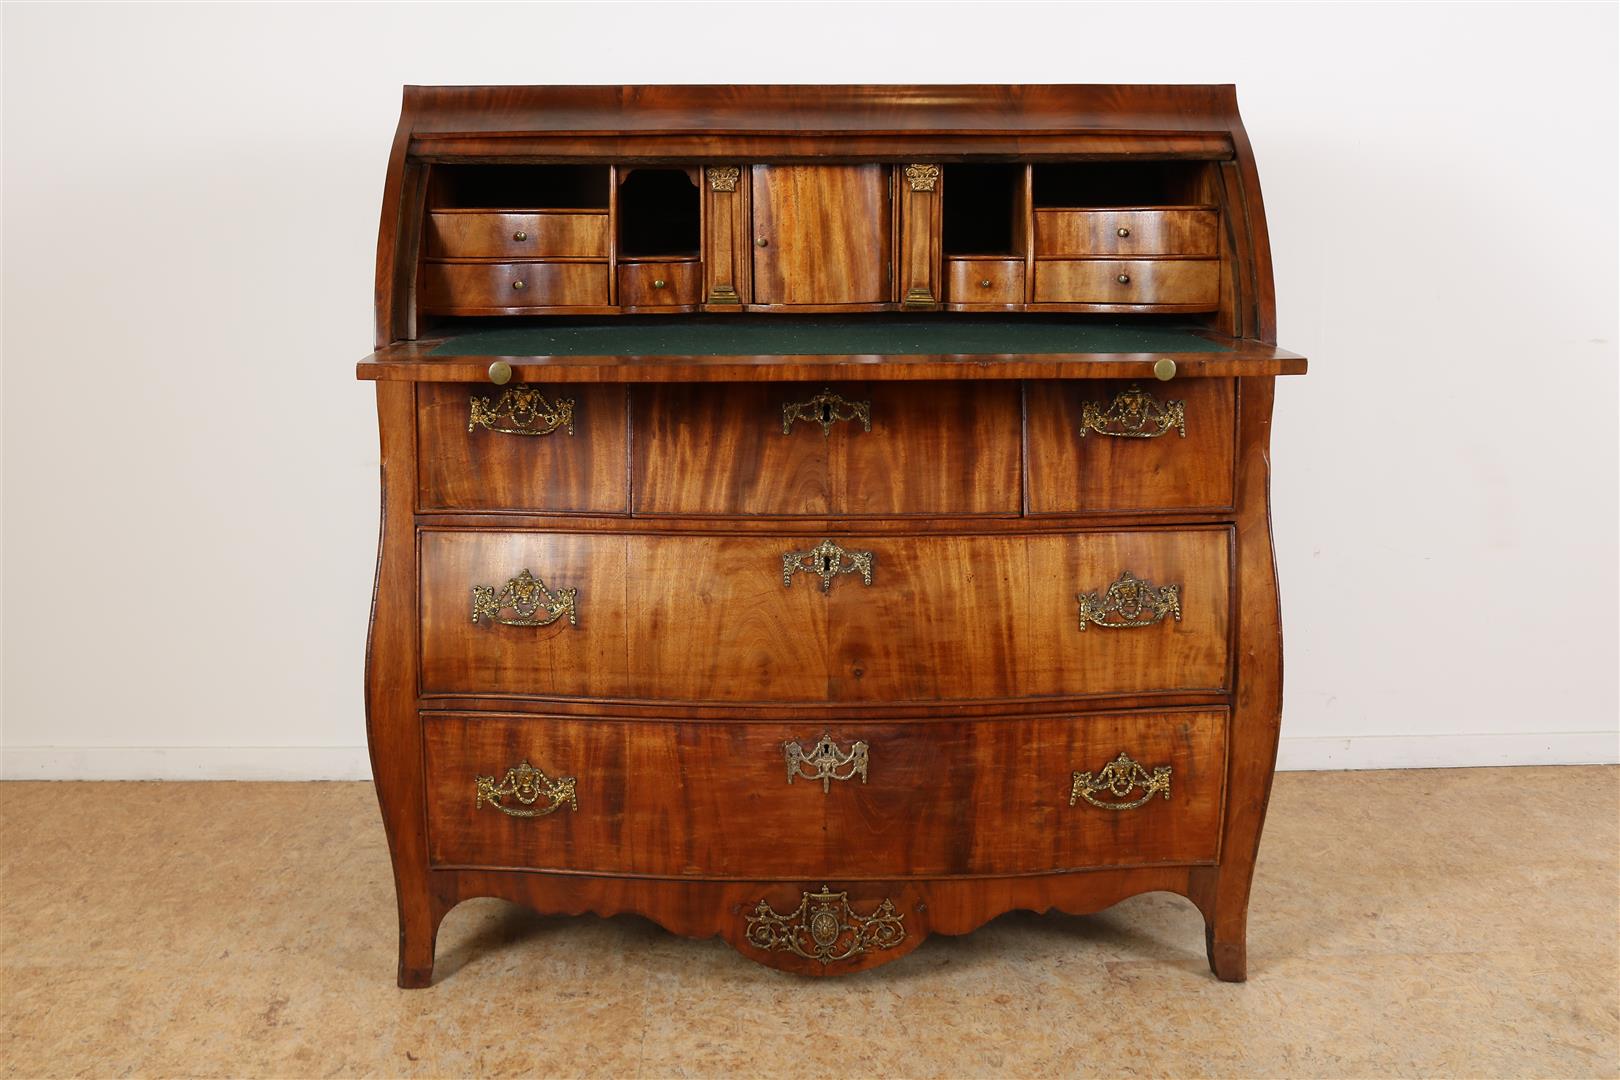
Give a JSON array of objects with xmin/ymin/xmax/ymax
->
[{"xmin": 632, "ymin": 382, "xmax": 1019, "ymax": 517}]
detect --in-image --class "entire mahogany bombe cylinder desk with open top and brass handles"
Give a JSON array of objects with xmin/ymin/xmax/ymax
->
[{"xmin": 358, "ymin": 86, "xmax": 1306, "ymax": 986}]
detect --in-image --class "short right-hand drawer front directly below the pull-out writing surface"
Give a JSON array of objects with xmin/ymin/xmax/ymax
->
[{"xmin": 1024, "ymin": 379, "xmax": 1238, "ymax": 513}]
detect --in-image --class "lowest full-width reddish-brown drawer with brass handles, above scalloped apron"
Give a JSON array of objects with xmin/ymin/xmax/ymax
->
[{"xmin": 423, "ymin": 708, "xmax": 1226, "ymax": 881}]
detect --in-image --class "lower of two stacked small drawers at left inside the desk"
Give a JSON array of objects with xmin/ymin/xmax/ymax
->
[{"xmin": 421, "ymin": 261, "xmax": 611, "ymax": 314}]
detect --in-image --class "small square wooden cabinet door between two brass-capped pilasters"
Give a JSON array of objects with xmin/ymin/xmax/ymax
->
[{"xmin": 753, "ymin": 165, "xmax": 891, "ymax": 304}]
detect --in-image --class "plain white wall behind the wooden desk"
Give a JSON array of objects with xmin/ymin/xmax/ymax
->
[{"xmin": 0, "ymin": 3, "xmax": 1620, "ymax": 777}]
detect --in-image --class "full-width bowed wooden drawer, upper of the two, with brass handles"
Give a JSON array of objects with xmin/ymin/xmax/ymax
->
[{"xmin": 420, "ymin": 526, "xmax": 1231, "ymax": 704}]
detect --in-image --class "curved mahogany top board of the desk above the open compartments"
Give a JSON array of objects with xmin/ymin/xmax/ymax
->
[{"xmin": 388, "ymin": 84, "xmax": 1241, "ymax": 162}]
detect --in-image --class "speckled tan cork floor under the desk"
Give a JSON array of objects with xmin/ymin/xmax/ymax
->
[{"xmin": 0, "ymin": 767, "xmax": 1620, "ymax": 1077}]
